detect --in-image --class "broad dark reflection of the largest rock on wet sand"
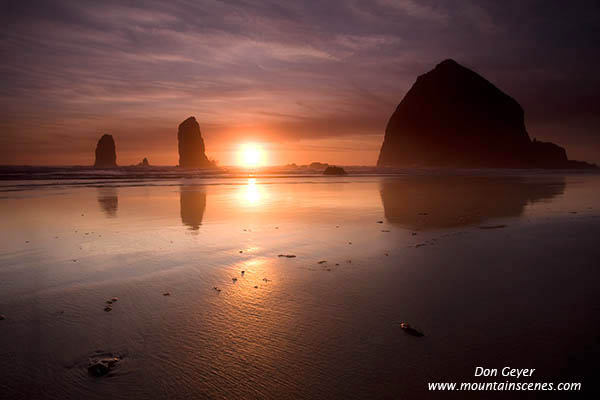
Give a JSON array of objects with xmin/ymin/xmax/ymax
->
[{"xmin": 381, "ymin": 176, "xmax": 565, "ymax": 229}]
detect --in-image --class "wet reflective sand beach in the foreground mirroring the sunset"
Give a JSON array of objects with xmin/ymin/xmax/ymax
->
[{"xmin": 0, "ymin": 175, "xmax": 600, "ymax": 399}]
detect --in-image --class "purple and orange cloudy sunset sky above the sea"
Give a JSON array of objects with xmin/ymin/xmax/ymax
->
[{"xmin": 0, "ymin": 0, "xmax": 600, "ymax": 165}]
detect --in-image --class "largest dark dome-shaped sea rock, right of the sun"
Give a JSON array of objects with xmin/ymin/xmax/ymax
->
[{"xmin": 377, "ymin": 60, "xmax": 594, "ymax": 168}]
